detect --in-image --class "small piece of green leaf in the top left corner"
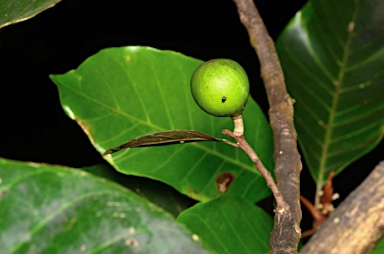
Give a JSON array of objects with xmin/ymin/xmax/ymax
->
[{"xmin": 0, "ymin": 0, "xmax": 61, "ymax": 28}]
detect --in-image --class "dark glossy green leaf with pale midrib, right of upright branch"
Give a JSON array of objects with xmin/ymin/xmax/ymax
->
[{"xmin": 277, "ymin": 0, "xmax": 384, "ymax": 186}]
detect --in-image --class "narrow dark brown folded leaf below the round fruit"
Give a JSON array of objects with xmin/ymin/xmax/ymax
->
[{"xmin": 103, "ymin": 130, "xmax": 222, "ymax": 155}]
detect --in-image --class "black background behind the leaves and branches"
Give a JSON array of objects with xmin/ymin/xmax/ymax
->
[{"xmin": 0, "ymin": 0, "xmax": 384, "ymax": 234}]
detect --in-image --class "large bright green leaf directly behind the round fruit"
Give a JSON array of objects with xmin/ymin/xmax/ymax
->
[{"xmin": 51, "ymin": 47, "xmax": 273, "ymax": 202}]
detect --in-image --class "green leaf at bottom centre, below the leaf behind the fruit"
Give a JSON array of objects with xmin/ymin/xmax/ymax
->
[{"xmin": 178, "ymin": 195, "xmax": 273, "ymax": 254}]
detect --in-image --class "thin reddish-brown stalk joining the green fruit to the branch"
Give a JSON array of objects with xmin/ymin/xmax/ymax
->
[{"xmin": 222, "ymin": 115, "xmax": 289, "ymax": 214}]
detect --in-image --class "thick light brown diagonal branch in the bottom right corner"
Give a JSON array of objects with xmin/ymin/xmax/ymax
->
[{"xmin": 300, "ymin": 161, "xmax": 384, "ymax": 254}]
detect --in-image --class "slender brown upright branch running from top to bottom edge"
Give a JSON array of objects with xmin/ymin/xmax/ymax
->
[{"xmin": 234, "ymin": 0, "xmax": 302, "ymax": 253}]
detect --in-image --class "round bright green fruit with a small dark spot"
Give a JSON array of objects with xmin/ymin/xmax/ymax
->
[{"xmin": 191, "ymin": 59, "xmax": 249, "ymax": 117}]
